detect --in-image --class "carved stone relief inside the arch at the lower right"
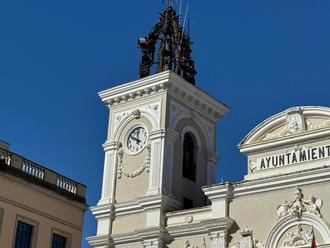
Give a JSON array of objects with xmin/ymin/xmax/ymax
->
[{"xmin": 281, "ymin": 224, "xmax": 313, "ymax": 248}]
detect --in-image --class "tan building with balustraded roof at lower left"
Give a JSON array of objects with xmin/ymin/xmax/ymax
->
[{"xmin": 0, "ymin": 141, "xmax": 87, "ymax": 248}]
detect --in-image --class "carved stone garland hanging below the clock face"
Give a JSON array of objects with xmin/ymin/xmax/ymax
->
[{"xmin": 117, "ymin": 143, "xmax": 151, "ymax": 179}]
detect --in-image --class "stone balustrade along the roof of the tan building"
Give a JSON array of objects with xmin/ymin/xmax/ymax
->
[{"xmin": 0, "ymin": 148, "xmax": 86, "ymax": 203}]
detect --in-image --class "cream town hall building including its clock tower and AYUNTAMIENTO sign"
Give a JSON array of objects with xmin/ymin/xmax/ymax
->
[{"xmin": 88, "ymin": 4, "xmax": 330, "ymax": 248}]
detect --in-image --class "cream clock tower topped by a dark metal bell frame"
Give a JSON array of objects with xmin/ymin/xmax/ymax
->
[{"xmin": 89, "ymin": 7, "xmax": 229, "ymax": 248}]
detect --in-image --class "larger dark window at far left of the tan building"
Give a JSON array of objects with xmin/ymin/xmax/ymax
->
[{"xmin": 14, "ymin": 221, "xmax": 33, "ymax": 248}]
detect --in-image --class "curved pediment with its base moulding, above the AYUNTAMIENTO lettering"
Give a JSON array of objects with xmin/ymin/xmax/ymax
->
[{"xmin": 238, "ymin": 106, "xmax": 330, "ymax": 153}]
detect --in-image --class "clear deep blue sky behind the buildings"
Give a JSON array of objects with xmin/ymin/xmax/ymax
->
[{"xmin": 0, "ymin": 0, "xmax": 330, "ymax": 248}]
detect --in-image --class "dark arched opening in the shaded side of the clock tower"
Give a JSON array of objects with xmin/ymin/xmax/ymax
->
[{"xmin": 182, "ymin": 133, "xmax": 196, "ymax": 182}]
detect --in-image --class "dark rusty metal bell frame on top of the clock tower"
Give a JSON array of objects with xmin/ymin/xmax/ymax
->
[{"xmin": 138, "ymin": 6, "xmax": 196, "ymax": 85}]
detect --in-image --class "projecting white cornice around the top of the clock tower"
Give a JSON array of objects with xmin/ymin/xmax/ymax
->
[{"xmin": 99, "ymin": 71, "xmax": 229, "ymax": 121}]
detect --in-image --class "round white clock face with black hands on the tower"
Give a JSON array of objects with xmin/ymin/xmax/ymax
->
[{"xmin": 126, "ymin": 127, "xmax": 148, "ymax": 153}]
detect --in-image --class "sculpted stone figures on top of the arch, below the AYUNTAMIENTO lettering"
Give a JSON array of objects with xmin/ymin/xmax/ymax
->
[{"xmin": 276, "ymin": 187, "xmax": 323, "ymax": 219}]
